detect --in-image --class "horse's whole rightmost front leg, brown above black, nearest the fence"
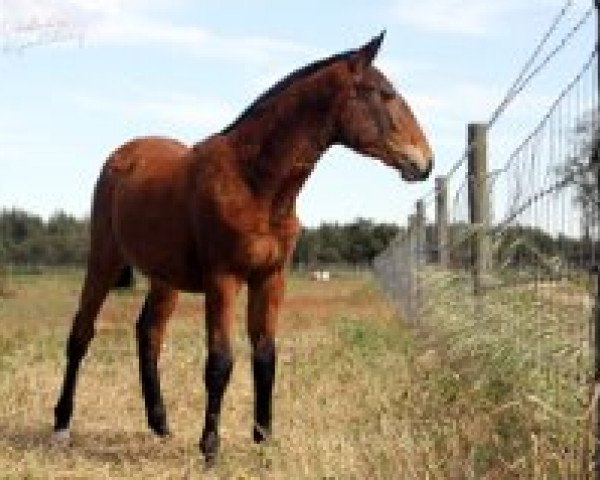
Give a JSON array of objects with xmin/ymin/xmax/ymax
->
[{"xmin": 248, "ymin": 270, "xmax": 285, "ymax": 443}]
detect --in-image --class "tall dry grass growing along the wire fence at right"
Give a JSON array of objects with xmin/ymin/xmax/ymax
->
[{"xmin": 410, "ymin": 269, "xmax": 597, "ymax": 479}]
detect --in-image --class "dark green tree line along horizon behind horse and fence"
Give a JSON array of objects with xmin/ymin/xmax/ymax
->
[{"xmin": 0, "ymin": 209, "xmax": 598, "ymax": 268}]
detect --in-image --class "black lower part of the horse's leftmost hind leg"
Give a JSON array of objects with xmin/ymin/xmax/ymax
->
[{"xmin": 54, "ymin": 320, "xmax": 93, "ymax": 431}]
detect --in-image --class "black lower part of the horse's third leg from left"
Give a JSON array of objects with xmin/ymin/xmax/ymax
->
[{"xmin": 200, "ymin": 350, "xmax": 233, "ymax": 463}]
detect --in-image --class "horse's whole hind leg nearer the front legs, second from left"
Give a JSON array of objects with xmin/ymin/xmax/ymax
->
[{"xmin": 137, "ymin": 281, "xmax": 177, "ymax": 436}]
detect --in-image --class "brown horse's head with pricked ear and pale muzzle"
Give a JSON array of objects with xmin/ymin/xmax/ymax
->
[{"xmin": 337, "ymin": 33, "xmax": 433, "ymax": 181}]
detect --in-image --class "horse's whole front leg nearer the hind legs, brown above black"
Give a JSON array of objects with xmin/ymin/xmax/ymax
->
[{"xmin": 200, "ymin": 275, "xmax": 240, "ymax": 464}]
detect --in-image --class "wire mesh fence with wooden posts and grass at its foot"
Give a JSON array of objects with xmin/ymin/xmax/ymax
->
[{"xmin": 374, "ymin": 2, "xmax": 600, "ymax": 478}]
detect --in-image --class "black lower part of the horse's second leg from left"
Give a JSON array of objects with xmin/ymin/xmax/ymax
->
[{"xmin": 137, "ymin": 299, "xmax": 169, "ymax": 436}]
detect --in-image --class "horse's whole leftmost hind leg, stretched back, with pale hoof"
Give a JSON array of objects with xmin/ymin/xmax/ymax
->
[{"xmin": 54, "ymin": 248, "xmax": 124, "ymax": 439}]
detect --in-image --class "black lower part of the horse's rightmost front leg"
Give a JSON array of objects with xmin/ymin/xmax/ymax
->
[{"xmin": 252, "ymin": 339, "xmax": 276, "ymax": 443}]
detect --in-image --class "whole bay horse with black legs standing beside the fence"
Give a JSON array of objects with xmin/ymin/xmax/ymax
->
[{"xmin": 54, "ymin": 32, "xmax": 433, "ymax": 463}]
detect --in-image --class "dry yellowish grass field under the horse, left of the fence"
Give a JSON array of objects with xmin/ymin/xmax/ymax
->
[{"xmin": 0, "ymin": 271, "xmax": 585, "ymax": 479}]
